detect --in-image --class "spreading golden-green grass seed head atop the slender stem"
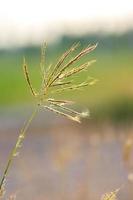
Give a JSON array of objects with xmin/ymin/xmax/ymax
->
[{"xmin": 23, "ymin": 43, "xmax": 97, "ymax": 122}]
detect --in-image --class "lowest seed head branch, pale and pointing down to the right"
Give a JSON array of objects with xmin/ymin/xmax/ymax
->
[{"xmin": 43, "ymin": 106, "xmax": 81, "ymax": 123}]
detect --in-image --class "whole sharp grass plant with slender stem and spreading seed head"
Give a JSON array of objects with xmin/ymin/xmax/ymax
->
[{"xmin": 0, "ymin": 43, "xmax": 97, "ymax": 198}]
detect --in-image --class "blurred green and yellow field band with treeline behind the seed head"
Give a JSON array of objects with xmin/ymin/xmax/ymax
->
[{"xmin": 0, "ymin": 33, "xmax": 133, "ymax": 120}]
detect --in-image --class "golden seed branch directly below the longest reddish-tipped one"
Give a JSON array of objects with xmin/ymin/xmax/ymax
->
[{"xmin": 59, "ymin": 60, "xmax": 96, "ymax": 79}]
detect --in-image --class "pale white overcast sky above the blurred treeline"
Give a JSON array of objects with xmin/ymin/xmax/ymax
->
[{"xmin": 0, "ymin": 0, "xmax": 133, "ymax": 48}]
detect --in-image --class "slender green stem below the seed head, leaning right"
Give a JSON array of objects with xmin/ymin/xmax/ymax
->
[{"xmin": 0, "ymin": 107, "xmax": 38, "ymax": 191}]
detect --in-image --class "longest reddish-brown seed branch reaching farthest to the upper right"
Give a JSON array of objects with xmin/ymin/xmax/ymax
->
[{"xmin": 49, "ymin": 44, "xmax": 97, "ymax": 85}]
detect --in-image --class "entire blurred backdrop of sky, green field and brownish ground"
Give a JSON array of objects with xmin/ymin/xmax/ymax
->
[{"xmin": 0, "ymin": 0, "xmax": 133, "ymax": 200}]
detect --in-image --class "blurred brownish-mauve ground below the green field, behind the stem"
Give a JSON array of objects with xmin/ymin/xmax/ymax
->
[{"xmin": 0, "ymin": 109, "xmax": 133, "ymax": 200}]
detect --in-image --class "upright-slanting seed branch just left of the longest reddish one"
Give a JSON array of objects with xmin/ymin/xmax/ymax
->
[{"xmin": 47, "ymin": 43, "xmax": 79, "ymax": 85}]
